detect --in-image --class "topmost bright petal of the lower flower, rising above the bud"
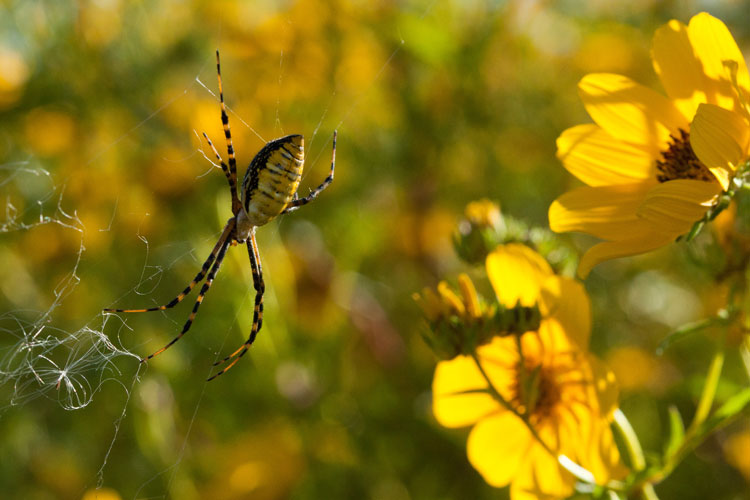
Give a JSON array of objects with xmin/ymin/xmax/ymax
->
[{"xmin": 487, "ymin": 243, "xmax": 553, "ymax": 307}]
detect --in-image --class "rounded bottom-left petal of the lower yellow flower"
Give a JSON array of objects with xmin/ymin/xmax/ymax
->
[{"xmin": 466, "ymin": 412, "xmax": 533, "ymax": 487}]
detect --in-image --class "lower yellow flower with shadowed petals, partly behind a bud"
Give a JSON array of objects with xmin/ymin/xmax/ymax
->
[{"xmin": 433, "ymin": 244, "xmax": 622, "ymax": 500}]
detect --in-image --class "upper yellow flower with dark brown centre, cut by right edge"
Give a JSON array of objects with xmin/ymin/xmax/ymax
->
[{"xmin": 549, "ymin": 13, "xmax": 750, "ymax": 277}]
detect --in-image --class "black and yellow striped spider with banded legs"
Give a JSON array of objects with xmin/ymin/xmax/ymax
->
[{"xmin": 104, "ymin": 50, "xmax": 337, "ymax": 381}]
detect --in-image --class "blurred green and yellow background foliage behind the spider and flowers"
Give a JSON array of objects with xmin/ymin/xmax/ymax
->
[{"xmin": 0, "ymin": 0, "xmax": 750, "ymax": 500}]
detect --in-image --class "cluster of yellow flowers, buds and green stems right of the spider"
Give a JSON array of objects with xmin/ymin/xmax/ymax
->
[{"xmin": 415, "ymin": 13, "xmax": 750, "ymax": 500}]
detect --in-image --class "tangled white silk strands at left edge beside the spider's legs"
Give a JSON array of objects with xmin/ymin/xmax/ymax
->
[{"xmin": 0, "ymin": 162, "xmax": 138, "ymax": 411}]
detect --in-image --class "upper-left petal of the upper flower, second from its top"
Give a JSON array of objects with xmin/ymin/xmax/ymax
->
[{"xmin": 578, "ymin": 73, "xmax": 688, "ymax": 153}]
